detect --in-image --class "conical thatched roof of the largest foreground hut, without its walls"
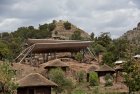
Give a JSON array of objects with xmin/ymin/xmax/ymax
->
[{"xmin": 17, "ymin": 73, "xmax": 57, "ymax": 87}]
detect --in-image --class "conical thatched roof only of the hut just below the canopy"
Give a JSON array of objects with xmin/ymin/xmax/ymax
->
[{"xmin": 43, "ymin": 59, "xmax": 68, "ymax": 68}]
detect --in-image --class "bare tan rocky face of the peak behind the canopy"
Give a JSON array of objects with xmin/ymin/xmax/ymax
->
[{"xmin": 52, "ymin": 20, "xmax": 90, "ymax": 39}]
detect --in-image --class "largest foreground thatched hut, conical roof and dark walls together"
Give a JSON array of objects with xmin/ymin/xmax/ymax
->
[{"xmin": 17, "ymin": 73, "xmax": 57, "ymax": 94}]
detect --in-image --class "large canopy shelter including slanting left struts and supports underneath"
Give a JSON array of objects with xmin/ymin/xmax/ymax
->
[{"xmin": 15, "ymin": 39, "xmax": 92, "ymax": 65}]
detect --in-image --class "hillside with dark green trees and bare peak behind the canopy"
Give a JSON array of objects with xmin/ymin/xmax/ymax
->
[{"xmin": 0, "ymin": 20, "xmax": 90, "ymax": 60}]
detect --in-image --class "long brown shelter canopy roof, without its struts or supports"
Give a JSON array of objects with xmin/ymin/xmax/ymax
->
[{"xmin": 27, "ymin": 39, "xmax": 92, "ymax": 53}]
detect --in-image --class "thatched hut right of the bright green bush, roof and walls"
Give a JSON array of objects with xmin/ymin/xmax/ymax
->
[{"xmin": 95, "ymin": 64, "xmax": 115, "ymax": 83}]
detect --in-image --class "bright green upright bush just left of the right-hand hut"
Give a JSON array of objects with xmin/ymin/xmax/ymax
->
[{"xmin": 89, "ymin": 72, "xmax": 99, "ymax": 86}]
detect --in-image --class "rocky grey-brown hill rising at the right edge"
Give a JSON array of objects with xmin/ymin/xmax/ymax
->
[{"xmin": 121, "ymin": 23, "xmax": 140, "ymax": 45}]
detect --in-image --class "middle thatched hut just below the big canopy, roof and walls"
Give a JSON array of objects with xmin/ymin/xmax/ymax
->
[{"xmin": 42, "ymin": 59, "xmax": 69, "ymax": 72}]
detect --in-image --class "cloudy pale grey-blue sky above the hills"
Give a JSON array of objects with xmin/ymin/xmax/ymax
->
[{"xmin": 0, "ymin": 0, "xmax": 140, "ymax": 38}]
